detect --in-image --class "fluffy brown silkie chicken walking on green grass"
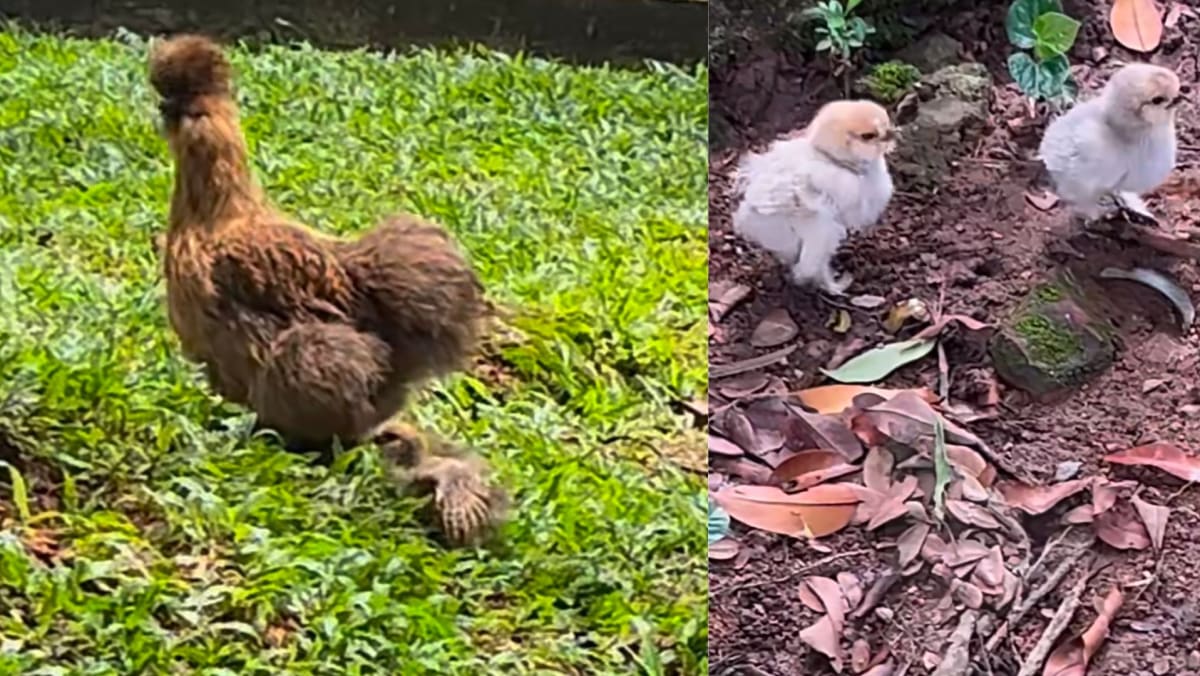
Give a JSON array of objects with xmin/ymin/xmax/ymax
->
[{"xmin": 150, "ymin": 36, "xmax": 505, "ymax": 544}]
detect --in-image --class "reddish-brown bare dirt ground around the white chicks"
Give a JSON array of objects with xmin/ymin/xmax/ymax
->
[{"xmin": 709, "ymin": 2, "xmax": 1200, "ymax": 676}]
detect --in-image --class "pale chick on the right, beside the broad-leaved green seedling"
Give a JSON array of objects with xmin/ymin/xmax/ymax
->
[{"xmin": 1038, "ymin": 64, "xmax": 1183, "ymax": 221}]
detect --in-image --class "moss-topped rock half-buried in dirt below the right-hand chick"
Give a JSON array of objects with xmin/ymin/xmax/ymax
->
[{"xmin": 990, "ymin": 276, "xmax": 1116, "ymax": 399}]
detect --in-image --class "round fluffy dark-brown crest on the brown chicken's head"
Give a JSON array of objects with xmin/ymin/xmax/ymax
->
[{"xmin": 150, "ymin": 35, "xmax": 232, "ymax": 103}]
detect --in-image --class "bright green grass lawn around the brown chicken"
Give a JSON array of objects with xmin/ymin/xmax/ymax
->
[{"xmin": 0, "ymin": 24, "xmax": 707, "ymax": 676}]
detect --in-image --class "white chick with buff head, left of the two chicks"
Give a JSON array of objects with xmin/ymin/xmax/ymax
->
[{"xmin": 733, "ymin": 101, "xmax": 894, "ymax": 295}]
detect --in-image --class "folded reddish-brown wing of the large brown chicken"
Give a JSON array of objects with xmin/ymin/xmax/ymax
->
[{"xmin": 212, "ymin": 223, "xmax": 353, "ymax": 322}]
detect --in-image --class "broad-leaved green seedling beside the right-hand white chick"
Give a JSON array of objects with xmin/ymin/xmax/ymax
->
[{"xmin": 1004, "ymin": 0, "xmax": 1080, "ymax": 101}]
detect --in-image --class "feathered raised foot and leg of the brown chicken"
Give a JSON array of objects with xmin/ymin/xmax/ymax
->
[{"xmin": 374, "ymin": 423, "xmax": 508, "ymax": 546}]
